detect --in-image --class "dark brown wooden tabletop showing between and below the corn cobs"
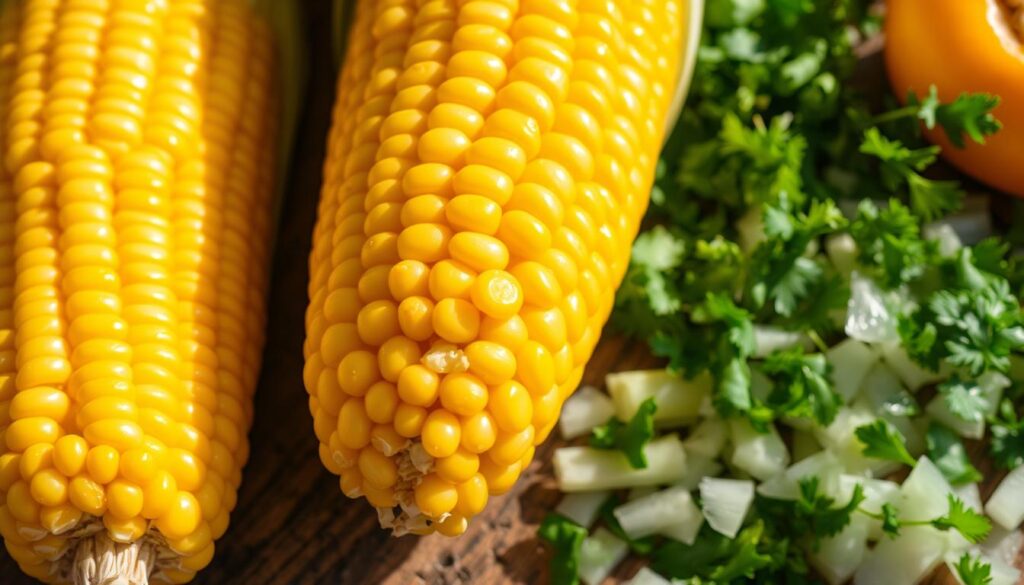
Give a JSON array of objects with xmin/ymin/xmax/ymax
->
[{"xmin": 0, "ymin": 0, "xmax": 1019, "ymax": 585}]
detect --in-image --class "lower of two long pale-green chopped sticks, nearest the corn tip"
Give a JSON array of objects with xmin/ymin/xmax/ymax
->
[{"xmin": 554, "ymin": 434, "xmax": 686, "ymax": 492}]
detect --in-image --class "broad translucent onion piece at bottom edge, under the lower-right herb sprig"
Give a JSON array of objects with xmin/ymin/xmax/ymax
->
[{"xmin": 853, "ymin": 527, "xmax": 946, "ymax": 585}]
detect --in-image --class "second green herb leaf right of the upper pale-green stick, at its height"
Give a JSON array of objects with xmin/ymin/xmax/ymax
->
[{"xmin": 762, "ymin": 346, "xmax": 843, "ymax": 426}]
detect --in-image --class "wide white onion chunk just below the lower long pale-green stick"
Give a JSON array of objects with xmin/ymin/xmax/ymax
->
[{"xmin": 612, "ymin": 487, "xmax": 703, "ymax": 544}]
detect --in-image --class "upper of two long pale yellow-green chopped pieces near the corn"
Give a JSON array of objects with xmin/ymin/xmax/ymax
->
[{"xmin": 605, "ymin": 370, "xmax": 712, "ymax": 426}]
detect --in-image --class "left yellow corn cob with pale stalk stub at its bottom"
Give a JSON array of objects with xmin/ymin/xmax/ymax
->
[{"xmin": 0, "ymin": 0, "xmax": 299, "ymax": 584}]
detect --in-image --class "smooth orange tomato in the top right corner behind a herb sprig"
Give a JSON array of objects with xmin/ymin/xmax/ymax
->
[{"xmin": 886, "ymin": 0, "xmax": 1024, "ymax": 197}]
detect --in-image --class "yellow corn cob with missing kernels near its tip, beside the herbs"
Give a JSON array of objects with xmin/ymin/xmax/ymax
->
[{"xmin": 303, "ymin": 0, "xmax": 685, "ymax": 536}]
